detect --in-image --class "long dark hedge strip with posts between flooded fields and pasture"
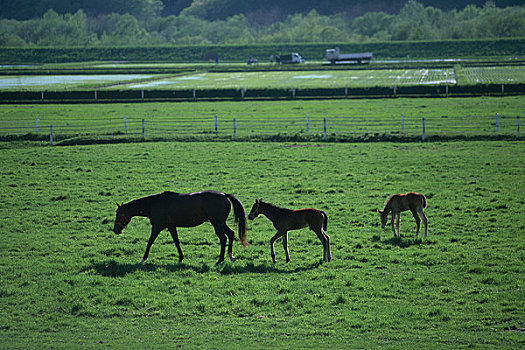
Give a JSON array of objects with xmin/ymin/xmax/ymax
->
[{"xmin": 0, "ymin": 84, "xmax": 525, "ymax": 103}]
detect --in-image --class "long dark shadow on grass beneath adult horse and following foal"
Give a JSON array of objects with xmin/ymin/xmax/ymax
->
[{"xmin": 82, "ymin": 260, "xmax": 322, "ymax": 277}]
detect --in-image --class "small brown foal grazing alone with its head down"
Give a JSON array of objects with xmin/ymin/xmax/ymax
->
[{"xmin": 378, "ymin": 192, "xmax": 428, "ymax": 237}]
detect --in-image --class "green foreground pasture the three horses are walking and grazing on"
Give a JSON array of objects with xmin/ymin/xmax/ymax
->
[{"xmin": 0, "ymin": 141, "xmax": 525, "ymax": 349}]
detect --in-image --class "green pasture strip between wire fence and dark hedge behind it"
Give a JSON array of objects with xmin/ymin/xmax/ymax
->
[{"xmin": 0, "ymin": 96, "xmax": 525, "ymax": 144}]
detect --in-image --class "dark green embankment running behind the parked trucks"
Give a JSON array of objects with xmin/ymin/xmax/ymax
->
[{"xmin": 0, "ymin": 38, "xmax": 525, "ymax": 64}]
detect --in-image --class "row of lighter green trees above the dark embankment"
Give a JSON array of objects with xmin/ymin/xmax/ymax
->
[{"xmin": 0, "ymin": 0, "xmax": 525, "ymax": 47}]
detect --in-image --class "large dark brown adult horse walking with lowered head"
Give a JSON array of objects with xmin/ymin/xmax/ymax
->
[{"xmin": 113, "ymin": 191, "xmax": 248, "ymax": 264}]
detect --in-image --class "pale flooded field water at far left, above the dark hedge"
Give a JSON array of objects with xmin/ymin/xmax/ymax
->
[{"xmin": 0, "ymin": 74, "xmax": 152, "ymax": 89}]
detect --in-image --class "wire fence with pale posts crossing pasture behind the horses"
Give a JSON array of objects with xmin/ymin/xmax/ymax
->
[{"xmin": 0, "ymin": 113, "xmax": 520, "ymax": 142}]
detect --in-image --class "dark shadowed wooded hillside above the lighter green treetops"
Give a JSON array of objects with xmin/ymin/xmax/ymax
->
[{"xmin": 0, "ymin": 0, "xmax": 523, "ymax": 24}]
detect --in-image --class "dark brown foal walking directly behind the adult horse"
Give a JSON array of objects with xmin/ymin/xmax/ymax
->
[{"xmin": 248, "ymin": 198, "xmax": 332, "ymax": 262}]
